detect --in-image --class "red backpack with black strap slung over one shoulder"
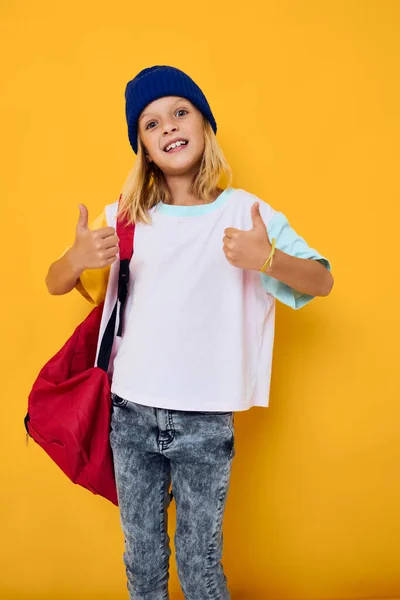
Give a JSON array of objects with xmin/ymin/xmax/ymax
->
[{"xmin": 24, "ymin": 203, "xmax": 135, "ymax": 505}]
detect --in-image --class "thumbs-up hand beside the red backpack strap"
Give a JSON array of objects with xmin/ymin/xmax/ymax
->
[{"xmin": 71, "ymin": 204, "xmax": 119, "ymax": 271}]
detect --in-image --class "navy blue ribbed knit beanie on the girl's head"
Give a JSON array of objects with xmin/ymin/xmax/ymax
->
[{"xmin": 125, "ymin": 65, "xmax": 217, "ymax": 154}]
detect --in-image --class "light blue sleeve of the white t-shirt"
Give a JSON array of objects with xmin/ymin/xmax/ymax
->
[{"xmin": 260, "ymin": 212, "xmax": 331, "ymax": 310}]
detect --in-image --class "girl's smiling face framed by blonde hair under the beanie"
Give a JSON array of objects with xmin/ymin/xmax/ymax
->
[{"xmin": 138, "ymin": 96, "xmax": 205, "ymax": 175}]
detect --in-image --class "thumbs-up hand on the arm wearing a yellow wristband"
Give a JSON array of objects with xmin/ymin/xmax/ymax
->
[{"xmin": 223, "ymin": 202, "xmax": 272, "ymax": 271}]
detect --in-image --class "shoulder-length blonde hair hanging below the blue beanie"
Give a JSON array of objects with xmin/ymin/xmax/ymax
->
[{"xmin": 118, "ymin": 115, "xmax": 232, "ymax": 224}]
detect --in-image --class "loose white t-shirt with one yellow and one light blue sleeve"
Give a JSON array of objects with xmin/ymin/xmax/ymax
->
[{"xmin": 63, "ymin": 187, "xmax": 331, "ymax": 412}]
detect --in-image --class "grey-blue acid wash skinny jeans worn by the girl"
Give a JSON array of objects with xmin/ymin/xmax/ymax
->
[{"xmin": 110, "ymin": 393, "xmax": 235, "ymax": 600}]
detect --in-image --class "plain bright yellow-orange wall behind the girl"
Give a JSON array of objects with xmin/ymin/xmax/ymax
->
[{"xmin": 0, "ymin": 0, "xmax": 400, "ymax": 600}]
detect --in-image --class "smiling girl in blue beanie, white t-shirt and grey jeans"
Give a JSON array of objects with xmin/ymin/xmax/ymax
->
[{"xmin": 46, "ymin": 66, "xmax": 333, "ymax": 600}]
